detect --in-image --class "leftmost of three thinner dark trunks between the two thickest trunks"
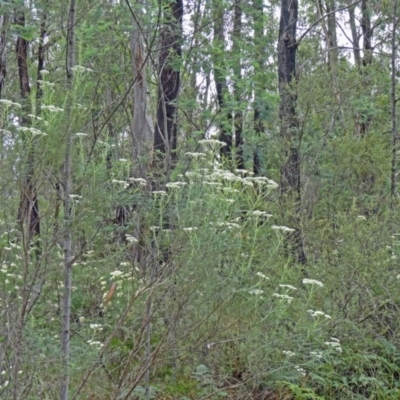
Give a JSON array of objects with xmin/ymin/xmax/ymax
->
[{"xmin": 213, "ymin": 0, "xmax": 233, "ymax": 160}]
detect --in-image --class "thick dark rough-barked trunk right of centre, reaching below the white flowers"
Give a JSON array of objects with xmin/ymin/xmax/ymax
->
[{"xmin": 278, "ymin": 0, "xmax": 307, "ymax": 264}]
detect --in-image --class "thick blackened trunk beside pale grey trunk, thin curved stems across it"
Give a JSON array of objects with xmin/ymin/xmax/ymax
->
[{"xmin": 154, "ymin": 0, "xmax": 183, "ymax": 180}]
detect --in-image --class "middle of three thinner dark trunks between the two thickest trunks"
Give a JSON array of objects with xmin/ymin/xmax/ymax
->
[{"xmin": 232, "ymin": 0, "xmax": 244, "ymax": 169}]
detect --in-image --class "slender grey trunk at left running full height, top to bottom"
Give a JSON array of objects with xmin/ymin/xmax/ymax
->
[{"xmin": 60, "ymin": 0, "xmax": 76, "ymax": 400}]
